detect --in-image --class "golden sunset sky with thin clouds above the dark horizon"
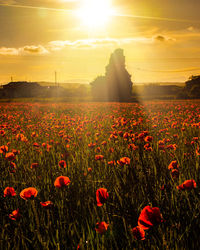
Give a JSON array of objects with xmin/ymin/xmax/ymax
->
[{"xmin": 0, "ymin": 0, "xmax": 200, "ymax": 83}]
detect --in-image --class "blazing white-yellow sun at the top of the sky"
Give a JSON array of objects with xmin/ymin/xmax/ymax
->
[{"xmin": 76, "ymin": 0, "xmax": 115, "ymax": 28}]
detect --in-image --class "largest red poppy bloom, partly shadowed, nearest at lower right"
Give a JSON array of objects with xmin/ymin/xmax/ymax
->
[{"xmin": 138, "ymin": 206, "xmax": 163, "ymax": 230}]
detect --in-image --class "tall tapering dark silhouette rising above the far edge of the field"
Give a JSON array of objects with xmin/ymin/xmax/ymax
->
[{"xmin": 90, "ymin": 49, "xmax": 133, "ymax": 101}]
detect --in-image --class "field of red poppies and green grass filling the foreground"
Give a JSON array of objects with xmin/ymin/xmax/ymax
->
[{"xmin": 0, "ymin": 101, "xmax": 200, "ymax": 249}]
